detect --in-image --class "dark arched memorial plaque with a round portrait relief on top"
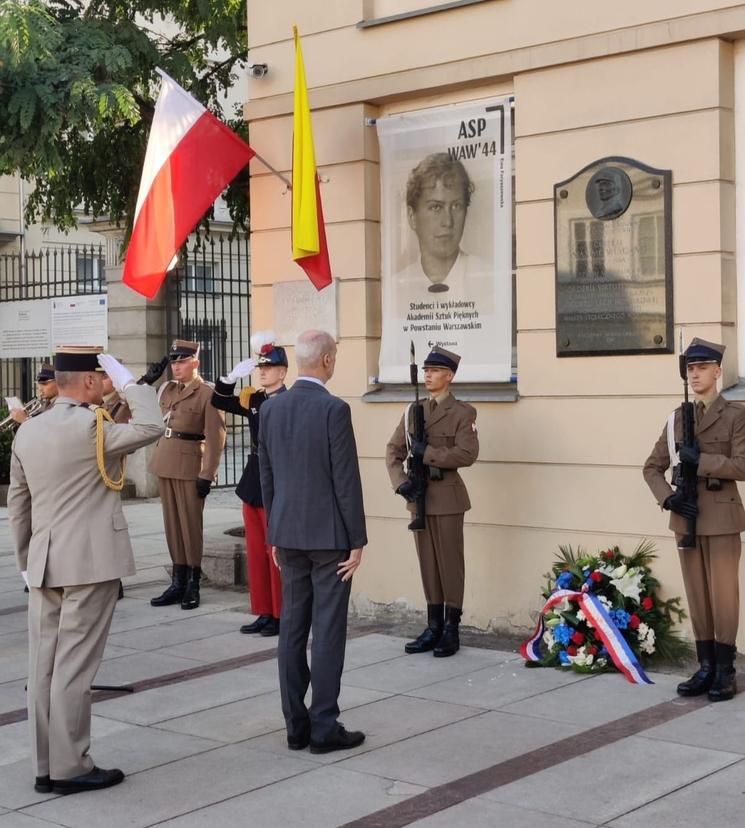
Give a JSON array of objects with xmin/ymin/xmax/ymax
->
[{"xmin": 554, "ymin": 157, "xmax": 674, "ymax": 356}]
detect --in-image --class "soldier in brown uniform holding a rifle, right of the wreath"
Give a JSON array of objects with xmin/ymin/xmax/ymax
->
[{"xmin": 644, "ymin": 338, "xmax": 745, "ymax": 701}]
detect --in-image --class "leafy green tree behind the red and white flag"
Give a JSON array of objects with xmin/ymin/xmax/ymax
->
[{"xmin": 0, "ymin": 0, "xmax": 248, "ymax": 234}]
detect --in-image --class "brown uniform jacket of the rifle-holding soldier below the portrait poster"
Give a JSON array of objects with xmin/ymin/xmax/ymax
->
[{"xmin": 385, "ymin": 394, "xmax": 479, "ymax": 515}]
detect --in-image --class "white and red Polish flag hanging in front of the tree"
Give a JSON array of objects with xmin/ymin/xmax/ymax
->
[{"xmin": 122, "ymin": 69, "xmax": 254, "ymax": 299}]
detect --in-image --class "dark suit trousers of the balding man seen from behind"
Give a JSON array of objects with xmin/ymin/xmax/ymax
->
[{"xmin": 278, "ymin": 549, "xmax": 351, "ymax": 742}]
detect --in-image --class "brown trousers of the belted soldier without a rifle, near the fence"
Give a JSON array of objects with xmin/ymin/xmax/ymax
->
[{"xmin": 158, "ymin": 477, "xmax": 204, "ymax": 566}]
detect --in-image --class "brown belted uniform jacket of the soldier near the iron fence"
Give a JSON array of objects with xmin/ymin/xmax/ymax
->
[{"xmin": 150, "ymin": 377, "xmax": 225, "ymax": 480}]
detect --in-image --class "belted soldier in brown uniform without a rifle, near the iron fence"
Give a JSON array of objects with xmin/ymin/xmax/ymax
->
[{"xmin": 150, "ymin": 339, "xmax": 225, "ymax": 609}]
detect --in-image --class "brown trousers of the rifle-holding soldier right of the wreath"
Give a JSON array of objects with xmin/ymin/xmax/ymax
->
[{"xmin": 678, "ymin": 535, "xmax": 740, "ymax": 645}]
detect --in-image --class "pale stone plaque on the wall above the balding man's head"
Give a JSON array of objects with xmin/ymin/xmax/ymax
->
[{"xmin": 272, "ymin": 279, "xmax": 339, "ymax": 345}]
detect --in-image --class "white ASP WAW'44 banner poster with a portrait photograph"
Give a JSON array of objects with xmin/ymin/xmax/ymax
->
[{"xmin": 377, "ymin": 98, "xmax": 512, "ymax": 383}]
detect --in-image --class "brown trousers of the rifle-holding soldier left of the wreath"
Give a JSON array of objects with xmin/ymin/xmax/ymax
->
[{"xmin": 414, "ymin": 512, "xmax": 466, "ymax": 609}]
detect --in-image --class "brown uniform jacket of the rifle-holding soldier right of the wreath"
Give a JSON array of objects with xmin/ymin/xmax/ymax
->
[{"xmin": 644, "ymin": 397, "xmax": 745, "ymax": 535}]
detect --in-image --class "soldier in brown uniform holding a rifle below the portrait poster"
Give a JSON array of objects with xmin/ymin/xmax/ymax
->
[{"xmin": 386, "ymin": 346, "xmax": 479, "ymax": 658}]
